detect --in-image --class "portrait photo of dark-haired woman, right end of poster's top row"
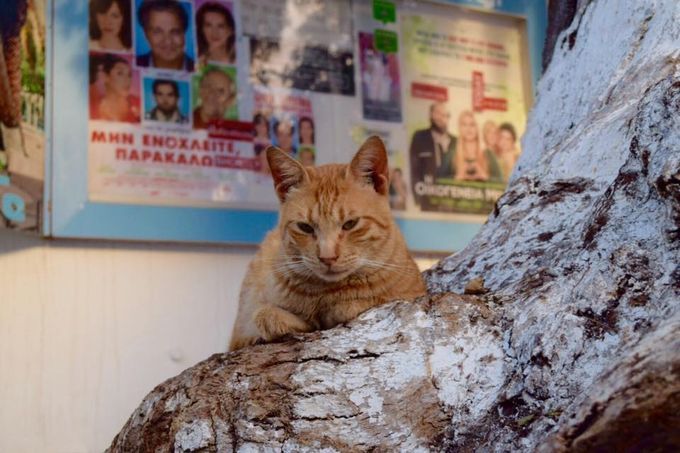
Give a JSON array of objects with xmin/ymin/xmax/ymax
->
[{"xmin": 195, "ymin": 0, "xmax": 236, "ymax": 66}]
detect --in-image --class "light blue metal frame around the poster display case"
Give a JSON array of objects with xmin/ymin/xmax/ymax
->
[{"xmin": 43, "ymin": 0, "xmax": 547, "ymax": 252}]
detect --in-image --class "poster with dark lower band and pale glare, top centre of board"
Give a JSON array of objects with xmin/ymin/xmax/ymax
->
[{"xmin": 242, "ymin": 0, "xmax": 355, "ymax": 96}]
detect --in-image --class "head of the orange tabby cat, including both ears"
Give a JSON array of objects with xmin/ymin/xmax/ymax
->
[{"xmin": 267, "ymin": 137, "xmax": 399, "ymax": 282}]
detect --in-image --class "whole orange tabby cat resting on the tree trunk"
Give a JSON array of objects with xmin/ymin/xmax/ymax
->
[{"xmin": 229, "ymin": 137, "xmax": 425, "ymax": 351}]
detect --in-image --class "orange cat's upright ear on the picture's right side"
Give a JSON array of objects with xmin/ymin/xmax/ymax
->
[{"xmin": 349, "ymin": 135, "xmax": 390, "ymax": 195}]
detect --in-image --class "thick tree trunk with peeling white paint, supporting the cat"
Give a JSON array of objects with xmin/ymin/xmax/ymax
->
[{"xmin": 110, "ymin": 0, "xmax": 680, "ymax": 452}]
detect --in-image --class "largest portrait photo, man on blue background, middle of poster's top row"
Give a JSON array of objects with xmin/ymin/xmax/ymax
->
[{"xmin": 134, "ymin": 0, "xmax": 196, "ymax": 72}]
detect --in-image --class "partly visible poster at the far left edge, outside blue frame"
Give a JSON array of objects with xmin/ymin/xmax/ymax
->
[{"xmin": 0, "ymin": 0, "xmax": 45, "ymax": 231}]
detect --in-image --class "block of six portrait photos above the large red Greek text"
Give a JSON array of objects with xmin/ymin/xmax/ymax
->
[{"xmin": 89, "ymin": 0, "xmax": 238, "ymax": 130}]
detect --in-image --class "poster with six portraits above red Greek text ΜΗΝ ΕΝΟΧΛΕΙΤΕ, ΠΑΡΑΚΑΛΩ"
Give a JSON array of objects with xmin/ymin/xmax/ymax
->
[{"xmin": 88, "ymin": 0, "xmax": 276, "ymax": 209}]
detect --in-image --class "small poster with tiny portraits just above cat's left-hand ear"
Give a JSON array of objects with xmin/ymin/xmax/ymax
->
[{"xmin": 253, "ymin": 88, "xmax": 317, "ymax": 174}]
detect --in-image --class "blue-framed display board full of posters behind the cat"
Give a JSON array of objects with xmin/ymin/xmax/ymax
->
[{"xmin": 43, "ymin": 0, "xmax": 546, "ymax": 252}]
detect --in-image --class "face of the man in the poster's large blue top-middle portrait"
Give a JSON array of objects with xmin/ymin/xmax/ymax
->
[{"xmin": 144, "ymin": 11, "xmax": 184, "ymax": 67}]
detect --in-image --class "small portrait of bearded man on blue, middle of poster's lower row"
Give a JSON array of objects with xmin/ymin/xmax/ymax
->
[{"xmin": 142, "ymin": 77, "xmax": 191, "ymax": 125}]
